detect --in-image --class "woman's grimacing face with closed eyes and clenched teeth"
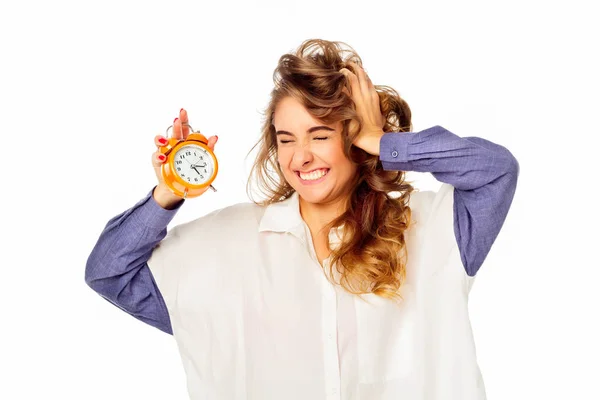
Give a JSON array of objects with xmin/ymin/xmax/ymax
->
[{"xmin": 273, "ymin": 97, "xmax": 357, "ymax": 204}]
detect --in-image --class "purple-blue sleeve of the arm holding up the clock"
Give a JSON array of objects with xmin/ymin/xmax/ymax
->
[{"xmin": 85, "ymin": 186, "xmax": 185, "ymax": 335}]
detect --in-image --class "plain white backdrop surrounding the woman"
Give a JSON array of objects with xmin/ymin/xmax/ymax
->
[{"xmin": 0, "ymin": 0, "xmax": 600, "ymax": 400}]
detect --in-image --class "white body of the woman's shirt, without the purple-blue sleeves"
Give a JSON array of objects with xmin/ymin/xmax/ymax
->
[{"xmin": 148, "ymin": 183, "xmax": 486, "ymax": 400}]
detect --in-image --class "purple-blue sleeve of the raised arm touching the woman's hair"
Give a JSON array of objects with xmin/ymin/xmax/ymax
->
[{"xmin": 379, "ymin": 125, "xmax": 519, "ymax": 276}]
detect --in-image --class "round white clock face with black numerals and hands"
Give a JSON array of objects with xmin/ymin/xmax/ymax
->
[{"xmin": 173, "ymin": 144, "xmax": 214, "ymax": 185}]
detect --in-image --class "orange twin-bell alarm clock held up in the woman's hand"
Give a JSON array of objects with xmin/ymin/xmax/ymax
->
[{"xmin": 159, "ymin": 124, "xmax": 219, "ymax": 199}]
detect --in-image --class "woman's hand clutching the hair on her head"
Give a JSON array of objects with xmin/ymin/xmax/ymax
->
[{"xmin": 340, "ymin": 62, "xmax": 385, "ymax": 155}]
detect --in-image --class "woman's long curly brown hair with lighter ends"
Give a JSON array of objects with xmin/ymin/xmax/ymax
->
[{"xmin": 246, "ymin": 39, "xmax": 414, "ymax": 299}]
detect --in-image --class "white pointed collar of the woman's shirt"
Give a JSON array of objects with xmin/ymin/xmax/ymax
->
[{"xmin": 258, "ymin": 192, "xmax": 343, "ymax": 249}]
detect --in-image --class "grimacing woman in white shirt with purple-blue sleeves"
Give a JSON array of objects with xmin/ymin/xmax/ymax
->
[{"xmin": 85, "ymin": 40, "xmax": 519, "ymax": 400}]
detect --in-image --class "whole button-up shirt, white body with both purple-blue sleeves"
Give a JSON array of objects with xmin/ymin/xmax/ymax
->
[{"xmin": 86, "ymin": 126, "xmax": 519, "ymax": 400}]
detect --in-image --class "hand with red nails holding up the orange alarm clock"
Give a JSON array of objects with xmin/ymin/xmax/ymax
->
[{"xmin": 152, "ymin": 108, "xmax": 218, "ymax": 208}]
